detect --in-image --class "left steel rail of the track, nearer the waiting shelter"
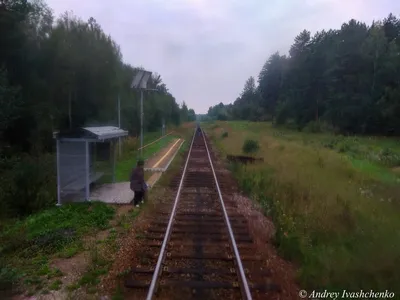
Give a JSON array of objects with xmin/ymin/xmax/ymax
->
[{"xmin": 146, "ymin": 127, "xmax": 197, "ymax": 300}]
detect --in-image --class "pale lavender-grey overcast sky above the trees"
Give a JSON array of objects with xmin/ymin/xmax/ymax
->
[{"xmin": 47, "ymin": 0, "xmax": 400, "ymax": 113}]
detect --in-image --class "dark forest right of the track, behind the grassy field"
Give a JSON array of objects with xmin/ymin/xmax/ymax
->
[{"xmin": 208, "ymin": 14, "xmax": 400, "ymax": 136}]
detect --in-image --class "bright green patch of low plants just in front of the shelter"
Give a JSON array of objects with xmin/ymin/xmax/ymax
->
[{"xmin": 0, "ymin": 202, "xmax": 114, "ymax": 254}]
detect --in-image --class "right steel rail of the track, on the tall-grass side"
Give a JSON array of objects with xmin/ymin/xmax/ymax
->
[{"xmin": 200, "ymin": 129, "xmax": 252, "ymax": 300}]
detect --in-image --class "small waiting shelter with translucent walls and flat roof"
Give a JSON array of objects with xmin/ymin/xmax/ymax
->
[{"xmin": 53, "ymin": 126, "xmax": 128, "ymax": 205}]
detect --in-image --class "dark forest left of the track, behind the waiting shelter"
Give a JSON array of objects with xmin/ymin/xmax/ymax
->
[{"xmin": 0, "ymin": 0, "xmax": 195, "ymax": 217}]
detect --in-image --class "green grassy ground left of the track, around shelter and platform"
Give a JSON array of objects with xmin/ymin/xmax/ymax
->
[{"xmin": 0, "ymin": 129, "xmax": 184, "ymax": 298}]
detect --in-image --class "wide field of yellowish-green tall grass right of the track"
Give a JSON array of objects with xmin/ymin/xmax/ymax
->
[{"xmin": 206, "ymin": 122, "xmax": 400, "ymax": 292}]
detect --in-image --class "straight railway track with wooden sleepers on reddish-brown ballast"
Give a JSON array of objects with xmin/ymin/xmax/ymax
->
[{"xmin": 125, "ymin": 128, "xmax": 280, "ymax": 300}]
